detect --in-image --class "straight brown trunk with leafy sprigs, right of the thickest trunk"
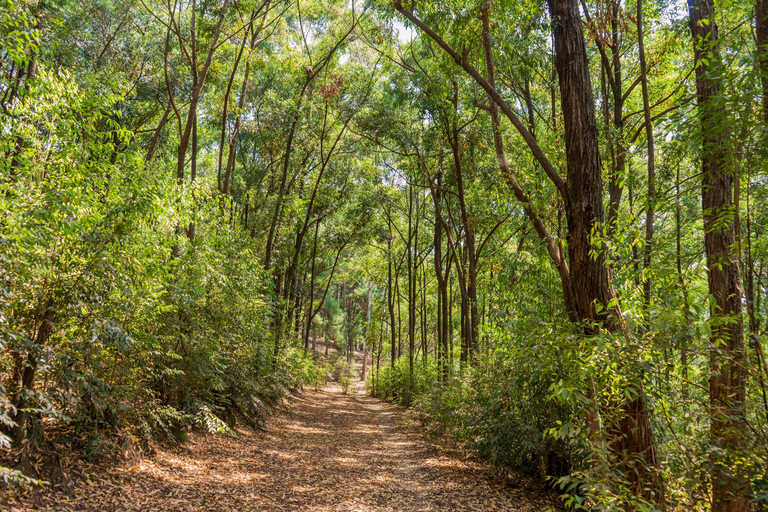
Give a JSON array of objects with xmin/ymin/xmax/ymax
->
[{"xmin": 688, "ymin": 0, "xmax": 750, "ymax": 512}]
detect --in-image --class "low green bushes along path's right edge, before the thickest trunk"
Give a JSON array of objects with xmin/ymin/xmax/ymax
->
[{"xmin": 367, "ymin": 330, "xmax": 581, "ymax": 477}]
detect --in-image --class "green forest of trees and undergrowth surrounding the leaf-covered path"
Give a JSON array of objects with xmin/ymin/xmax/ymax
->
[{"xmin": 0, "ymin": 0, "xmax": 768, "ymax": 512}]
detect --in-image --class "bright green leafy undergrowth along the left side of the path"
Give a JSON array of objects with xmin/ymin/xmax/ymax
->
[{"xmin": 0, "ymin": 0, "xmax": 324, "ymax": 466}]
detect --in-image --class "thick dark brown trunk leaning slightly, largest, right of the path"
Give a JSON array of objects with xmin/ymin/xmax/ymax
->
[{"xmin": 548, "ymin": 0, "xmax": 664, "ymax": 504}]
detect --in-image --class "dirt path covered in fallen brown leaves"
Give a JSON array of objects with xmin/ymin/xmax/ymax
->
[{"xmin": 0, "ymin": 342, "xmax": 560, "ymax": 512}]
